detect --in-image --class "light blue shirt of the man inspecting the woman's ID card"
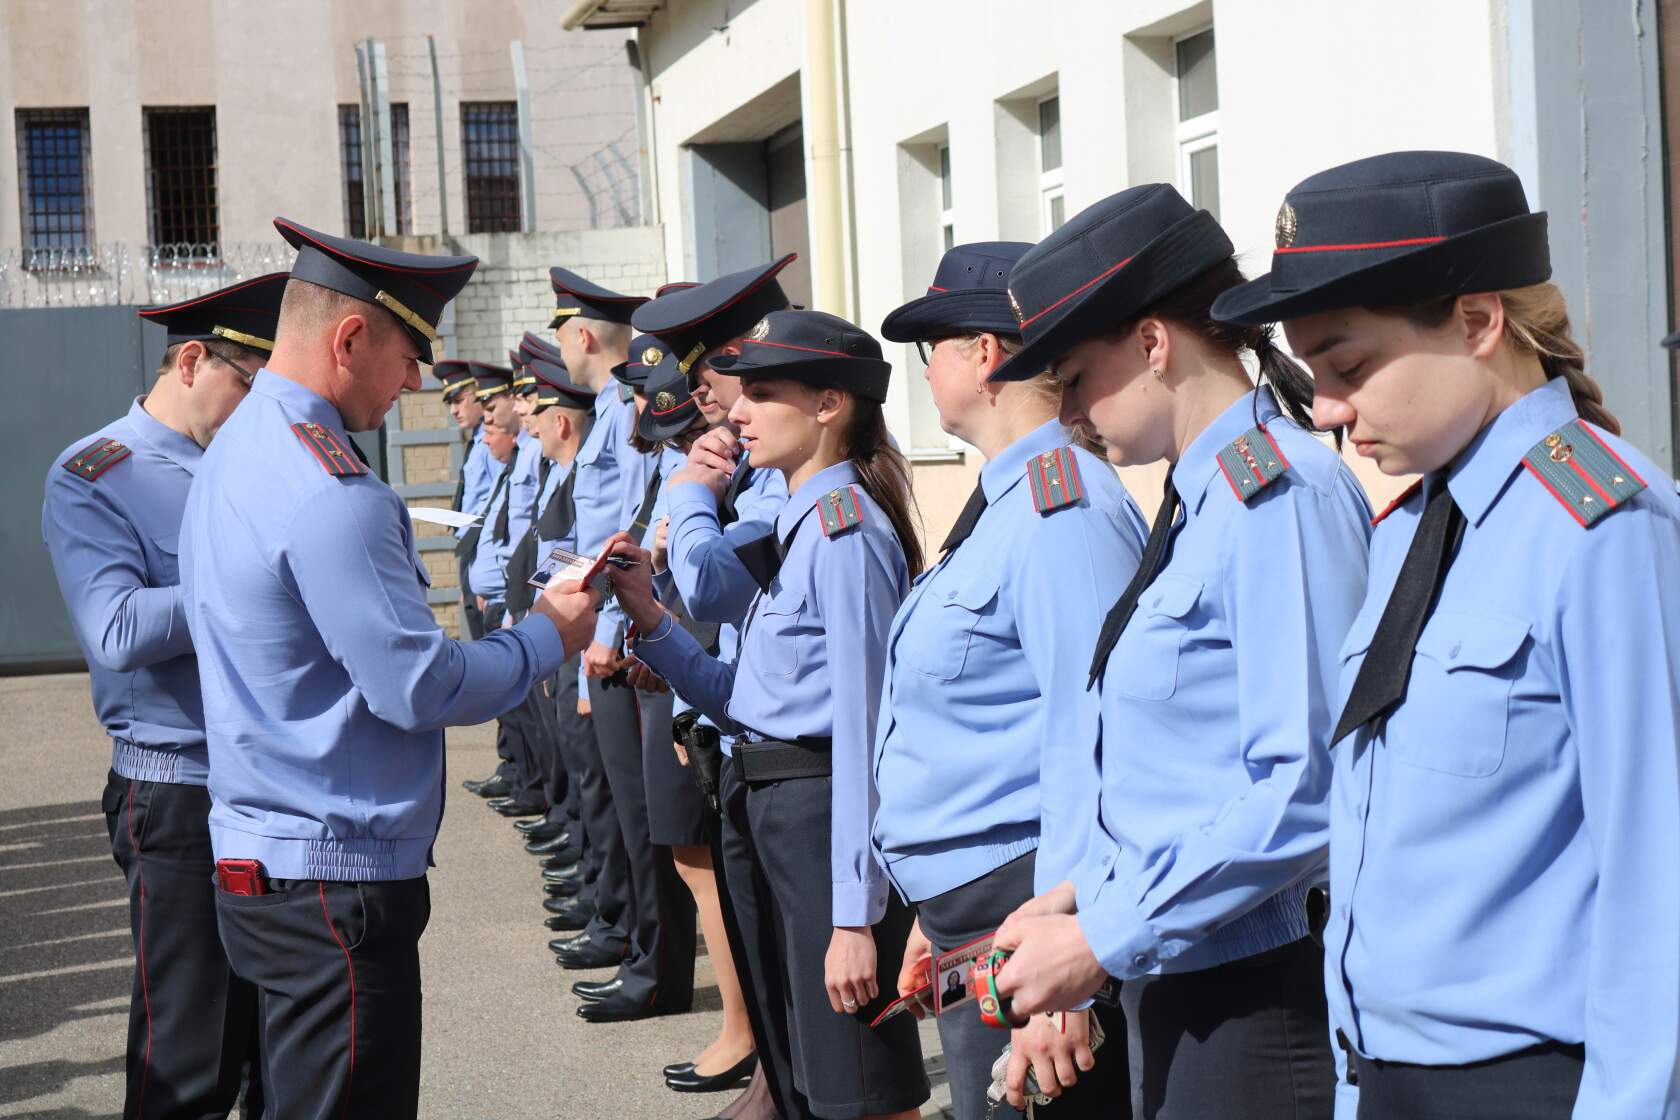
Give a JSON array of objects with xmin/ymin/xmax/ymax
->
[{"xmin": 181, "ymin": 369, "xmax": 564, "ymax": 880}]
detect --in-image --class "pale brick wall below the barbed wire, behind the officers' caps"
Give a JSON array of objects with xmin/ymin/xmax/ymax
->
[{"xmin": 388, "ymin": 227, "xmax": 665, "ymax": 638}]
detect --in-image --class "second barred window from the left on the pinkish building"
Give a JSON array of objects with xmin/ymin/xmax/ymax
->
[{"xmin": 143, "ymin": 107, "xmax": 222, "ymax": 257}]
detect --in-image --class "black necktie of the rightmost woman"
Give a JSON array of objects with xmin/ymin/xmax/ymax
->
[{"xmin": 1331, "ymin": 480, "xmax": 1465, "ymax": 747}]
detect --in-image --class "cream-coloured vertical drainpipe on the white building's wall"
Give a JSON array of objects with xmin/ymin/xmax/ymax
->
[{"xmin": 805, "ymin": 0, "xmax": 857, "ymax": 321}]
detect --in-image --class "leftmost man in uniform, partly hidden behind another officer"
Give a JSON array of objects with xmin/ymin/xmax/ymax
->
[{"xmin": 40, "ymin": 272, "xmax": 286, "ymax": 1117}]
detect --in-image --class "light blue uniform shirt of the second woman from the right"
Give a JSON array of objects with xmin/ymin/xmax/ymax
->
[{"xmin": 1070, "ymin": 390, "xmax": 1370, "ymax": 979}]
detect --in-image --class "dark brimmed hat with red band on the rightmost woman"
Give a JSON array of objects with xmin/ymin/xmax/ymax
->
[{"xmin": 1213, "ymin": 151, "xmax": 1552, "ymax": 324}]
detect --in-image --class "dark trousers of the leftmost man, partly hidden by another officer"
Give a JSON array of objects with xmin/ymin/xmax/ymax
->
[{"xmin": 101, "ymin": 771, "xmax": 262, "ymax": 1117}]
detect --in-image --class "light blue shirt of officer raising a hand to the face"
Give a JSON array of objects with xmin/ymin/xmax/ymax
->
[{"xmin": 662, "ymin": 462, "xmax": 788, "ymax": 756}]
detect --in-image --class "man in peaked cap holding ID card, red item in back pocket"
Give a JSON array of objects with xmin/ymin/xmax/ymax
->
[{"xmin": 181, "ymin": 218, "xmax": 595, "ymax": 1117}]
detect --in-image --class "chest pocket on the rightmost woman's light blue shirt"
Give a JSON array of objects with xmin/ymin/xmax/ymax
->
[{"xmin": 1384, "ymin": 611, "xmax": 1529, "ymax": 777}]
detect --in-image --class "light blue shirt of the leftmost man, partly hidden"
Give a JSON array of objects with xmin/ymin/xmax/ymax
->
[{"xmin": 40, "ymin": 398, "xmax": 210, "ymax": 786}]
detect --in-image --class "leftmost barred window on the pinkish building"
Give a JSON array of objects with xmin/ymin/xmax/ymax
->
[{"xmin": 17, "ymin": 109, "xmax": 94, "ymax": 249}]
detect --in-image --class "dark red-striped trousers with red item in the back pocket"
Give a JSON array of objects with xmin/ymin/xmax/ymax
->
[{"xmin": 215, "ymin": 877, "xmax": 432, "ymax": 1120}]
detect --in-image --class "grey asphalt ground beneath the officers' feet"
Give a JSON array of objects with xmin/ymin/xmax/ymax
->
[{"xmin": 0, "ymin": 675, "xmax": 949, "ymax": 1120}]
